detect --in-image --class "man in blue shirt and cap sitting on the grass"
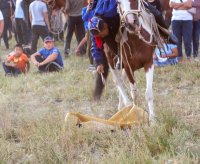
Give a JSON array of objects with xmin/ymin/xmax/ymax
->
[{"xmin": 31, "ymin": 36, "xmax": 63, "ymax": 72}]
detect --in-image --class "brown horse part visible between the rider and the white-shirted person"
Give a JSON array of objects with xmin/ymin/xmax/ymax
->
[{"xmin": 160, "ymin": 0, "xmax": 172, "ymax": 27}]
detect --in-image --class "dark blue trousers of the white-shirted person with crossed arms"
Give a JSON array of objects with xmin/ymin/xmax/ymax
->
[{"xmin": 172, "ymin": 20, "xmax": 193, "ymax": 58}]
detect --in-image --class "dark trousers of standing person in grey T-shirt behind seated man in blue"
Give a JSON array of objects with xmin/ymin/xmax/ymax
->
[{"xmin": 31, "ymin": 25, "xmax": 49, "ymax": 53}]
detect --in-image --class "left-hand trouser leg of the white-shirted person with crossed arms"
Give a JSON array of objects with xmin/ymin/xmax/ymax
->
[{"xmin": 172, "ymin": 20, "xmax": 183, "ymax": 60}]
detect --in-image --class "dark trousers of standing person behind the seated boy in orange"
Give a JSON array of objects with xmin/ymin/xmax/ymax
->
[{"xmin": 15, "ymin": 18, "xmax": 28, "ymax": 44}]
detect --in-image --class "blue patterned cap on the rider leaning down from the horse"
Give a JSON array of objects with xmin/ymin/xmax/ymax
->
[{"xmin": 88, "ymin": 16, "xmax": 104, "ymax": 35}]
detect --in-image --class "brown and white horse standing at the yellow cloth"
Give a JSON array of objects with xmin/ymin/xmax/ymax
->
[{"xmin": 49, "ymin": 0, "xmax": 155, "ymax": 120}]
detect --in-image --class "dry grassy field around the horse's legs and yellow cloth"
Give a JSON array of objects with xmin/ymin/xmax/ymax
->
[{"xmin": 0, "ymin": 38, "xmax": 200, "ymax": 164}]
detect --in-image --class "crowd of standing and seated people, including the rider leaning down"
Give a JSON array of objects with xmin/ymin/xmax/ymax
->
[{"xmin": 0, "ymin": 0, "xmax": 200, "ymax": 75}]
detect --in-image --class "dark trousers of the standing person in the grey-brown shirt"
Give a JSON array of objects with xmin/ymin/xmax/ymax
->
[{"xmin": 64, "ymin": 16, "xmax": 85, "ymax": 54}]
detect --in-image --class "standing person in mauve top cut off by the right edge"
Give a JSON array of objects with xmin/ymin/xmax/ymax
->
[{"xmin": 191, "ymin": 0, "xmax": 200, "ymax": 61}]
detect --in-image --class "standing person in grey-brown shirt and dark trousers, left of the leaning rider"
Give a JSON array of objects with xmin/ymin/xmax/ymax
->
[{"xmin": 64, "ymin": 0, "xmax": 85, "ymax": 56}]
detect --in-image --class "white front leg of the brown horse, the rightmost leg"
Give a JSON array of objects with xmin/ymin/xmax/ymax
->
[{"xmin": 145, "ymin": 64, "xmax": 155, "ymax": 121}]
